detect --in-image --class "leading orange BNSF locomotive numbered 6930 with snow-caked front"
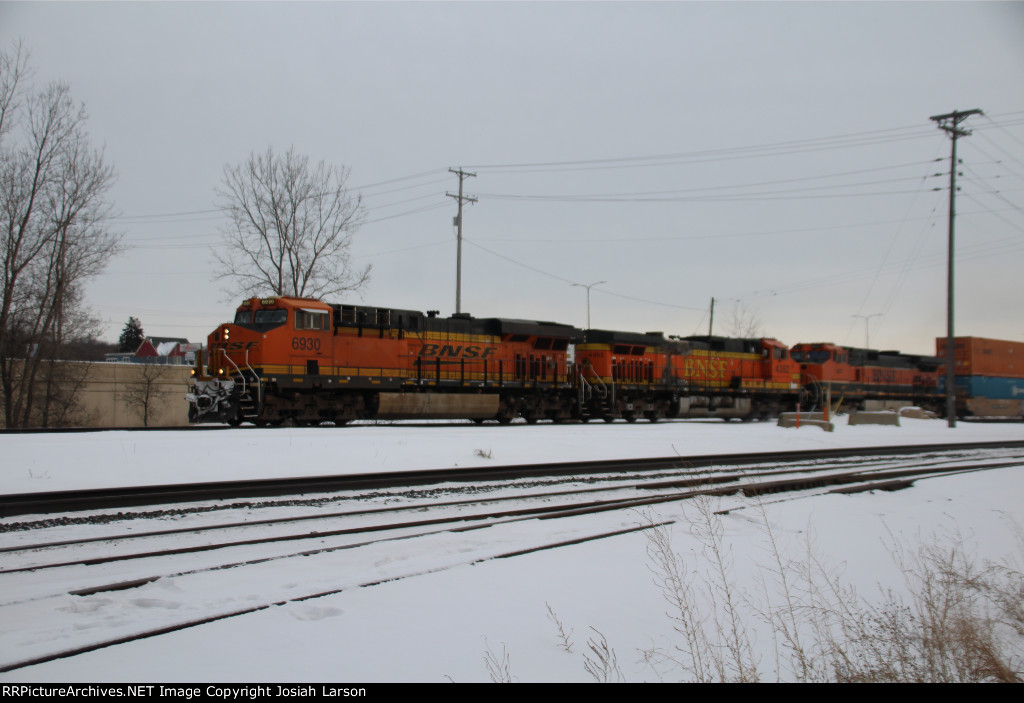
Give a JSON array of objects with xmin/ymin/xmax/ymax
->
[{"xmin": 188, "ymin": 297, "xmax": 579, "ymax": 425}]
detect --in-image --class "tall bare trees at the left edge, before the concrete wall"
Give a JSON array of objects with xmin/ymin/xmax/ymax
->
[{"xmin": 0, "ymin": 45, "xmax": 118, "ymax": 427}]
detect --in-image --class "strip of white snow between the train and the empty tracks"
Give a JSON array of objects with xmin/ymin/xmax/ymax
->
[{"xmin": 0, "ymin": 418, "xmax": 1024, "ymax": 493}]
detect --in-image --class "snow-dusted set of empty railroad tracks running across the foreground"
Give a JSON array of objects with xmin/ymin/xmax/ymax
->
[{"xmin": 0, "ymin": 443, "xmax": 1024, "ymax": 671}]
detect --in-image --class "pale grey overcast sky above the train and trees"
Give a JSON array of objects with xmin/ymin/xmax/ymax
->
[{"xmin": 0, "ymin": 2, "xmax": 1024, "ymax": 353}]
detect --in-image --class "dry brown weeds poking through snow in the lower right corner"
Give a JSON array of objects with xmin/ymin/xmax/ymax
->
[{"xmin": 642, "ymin": 506, "xmax": 1024, "ymax": 683}]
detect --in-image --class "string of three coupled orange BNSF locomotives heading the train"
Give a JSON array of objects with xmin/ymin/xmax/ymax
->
[{"xmin": 188, "ymin": 297, "xmax": 966, "ymax": 426}]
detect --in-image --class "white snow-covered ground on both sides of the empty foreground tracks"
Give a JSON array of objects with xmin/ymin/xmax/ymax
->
[{"xmin": 0, "ymin": 419, "xmax": 1024, "ymax": 683}]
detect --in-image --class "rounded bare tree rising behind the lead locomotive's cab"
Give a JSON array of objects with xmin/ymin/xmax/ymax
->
[{"xmin": 214, "ymin": 148, "xmax": 371, "ymax": 298}]
